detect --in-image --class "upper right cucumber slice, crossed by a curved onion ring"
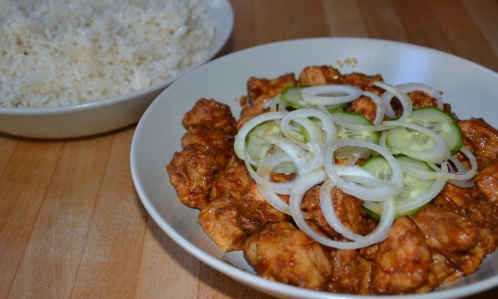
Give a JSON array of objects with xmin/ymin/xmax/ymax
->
[{"xmin": 386, "ymin": 107, "xmax": 463, "ymax": 154}]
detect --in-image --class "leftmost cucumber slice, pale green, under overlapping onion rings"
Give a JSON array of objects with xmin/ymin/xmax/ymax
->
[{"xmin": 246, "ymin": 120, "xmax": 282, "ymax": 167}]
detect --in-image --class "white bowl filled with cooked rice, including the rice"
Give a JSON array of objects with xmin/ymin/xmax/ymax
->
[{"xmin": 0, "ymin": 0, "xmax": 233, "ymax": 139}]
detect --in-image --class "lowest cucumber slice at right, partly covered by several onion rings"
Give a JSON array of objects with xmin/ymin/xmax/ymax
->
[{"xmin": 361, "ymin": 155, "xmax": 435, "ymax": 219}]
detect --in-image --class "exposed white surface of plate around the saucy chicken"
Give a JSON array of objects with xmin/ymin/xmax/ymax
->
[{"xmin": 131, "ymin": 38, "xmax": 498, "ymax": 299}]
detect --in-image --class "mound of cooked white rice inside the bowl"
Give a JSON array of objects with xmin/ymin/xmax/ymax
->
[{"xmin": 0, "ymin": 0, "xmax": 215, "ymax": 107}]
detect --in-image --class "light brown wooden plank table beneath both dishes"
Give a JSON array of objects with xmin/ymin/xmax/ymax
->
[{"xmin": 0, "ymin": 0, "xmax": 498, "ymax": 299}]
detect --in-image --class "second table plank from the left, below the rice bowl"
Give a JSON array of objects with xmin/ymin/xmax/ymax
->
[{"xmin": 9, "ymin": 135, "xmax": 113, "ymax": 298}]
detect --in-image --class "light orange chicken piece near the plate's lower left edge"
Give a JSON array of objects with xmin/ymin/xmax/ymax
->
[{"xmin": 199, "ymin": 194, "xmax": 249, "ymax": 252}]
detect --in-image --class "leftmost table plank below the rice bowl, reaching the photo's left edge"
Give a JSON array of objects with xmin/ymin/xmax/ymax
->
[{"xmin": 0, "ymin": 141, "xmax": 63, "ymax": 298}]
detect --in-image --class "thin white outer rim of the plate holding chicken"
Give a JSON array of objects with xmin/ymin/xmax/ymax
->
[{"xmin": 130, "ymin": 37, "xmax": 498, "ymax": 299}]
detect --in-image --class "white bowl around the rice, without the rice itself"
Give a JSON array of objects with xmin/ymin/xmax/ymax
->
[{"xmin": 0, "ymin": 0, "xmax": 234, "ymax": 138}]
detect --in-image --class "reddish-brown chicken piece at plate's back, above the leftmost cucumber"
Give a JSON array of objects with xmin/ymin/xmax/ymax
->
[{"xmin": 247, "ymin": 73, "xmax": 297, "ymax": 105}]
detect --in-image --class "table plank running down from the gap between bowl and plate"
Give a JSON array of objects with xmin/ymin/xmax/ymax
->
[{"xmin": 71, "ymin": 128, "xmax": 148, "ymax": 298}]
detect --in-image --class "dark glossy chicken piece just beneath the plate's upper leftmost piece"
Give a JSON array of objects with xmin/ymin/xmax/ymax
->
[{"xmin": 182, "ymin": 126, "xmax": 235, "ymax": 170}]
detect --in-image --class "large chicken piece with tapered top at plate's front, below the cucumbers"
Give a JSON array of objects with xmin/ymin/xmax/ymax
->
[{"xmin": 372, "ymin": 216, "xmax": 437, "ymax": 295}]
